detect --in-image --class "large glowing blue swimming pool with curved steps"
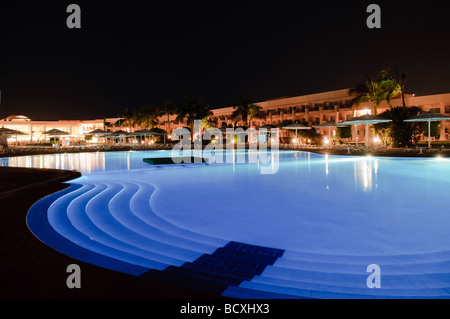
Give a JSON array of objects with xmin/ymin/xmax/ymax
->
[{"xmin": 0, "ymin": 151, "xmax": 450, "ymax": 298}]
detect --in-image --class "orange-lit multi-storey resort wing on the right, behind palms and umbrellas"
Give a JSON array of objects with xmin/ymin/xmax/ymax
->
[{"xmin": 164, "ymin": 89, "xmax": 450, "ymax": 141}]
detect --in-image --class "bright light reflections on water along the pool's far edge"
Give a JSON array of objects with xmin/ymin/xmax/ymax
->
[{"xmin": 0, "ymin": 151, "xmax": 450, "ymax": 192}]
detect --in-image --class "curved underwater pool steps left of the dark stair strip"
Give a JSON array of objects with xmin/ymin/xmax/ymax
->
[{"xmin": 42, "ymin": 183, "xmax": 227, "ymax": 269}]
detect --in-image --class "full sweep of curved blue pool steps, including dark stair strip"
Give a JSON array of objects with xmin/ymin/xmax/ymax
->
[{"xmin": 30, "ymin": 181, "xmax": 450, "ymax": 299}]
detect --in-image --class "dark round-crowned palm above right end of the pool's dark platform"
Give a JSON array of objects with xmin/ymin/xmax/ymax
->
[{"xmin": 176, "ymin": 95, "xmax": 214, "ymax": 140}]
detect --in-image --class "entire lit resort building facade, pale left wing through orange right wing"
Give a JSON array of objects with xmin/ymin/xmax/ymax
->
[{"xmin": 0, "ymin": 89, "xmax": 450, "ymax": 145}]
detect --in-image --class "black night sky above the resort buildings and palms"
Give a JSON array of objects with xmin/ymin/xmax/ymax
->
[{"xmin": 0, "ymin": 0, "xmax": 450, "ymax": 120}]
